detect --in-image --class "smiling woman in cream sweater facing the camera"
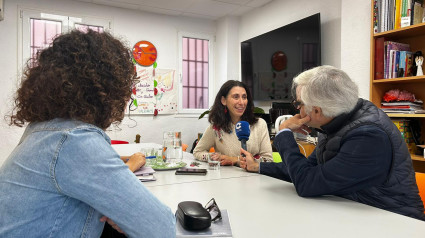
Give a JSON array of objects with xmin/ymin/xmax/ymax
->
[{"xmin": 193, "ymin": 80, "xmax": 273, "ymax": 165}]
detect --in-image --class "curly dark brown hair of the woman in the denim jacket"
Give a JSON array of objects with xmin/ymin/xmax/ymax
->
[{"xmin": 10, "ymin": 30, "xmax": 136, "ymax": 129}]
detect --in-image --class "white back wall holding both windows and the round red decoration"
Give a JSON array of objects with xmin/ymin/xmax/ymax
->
[{"xmin": 0, "ymin": 0, "xmax": 216, "ymax": 165}]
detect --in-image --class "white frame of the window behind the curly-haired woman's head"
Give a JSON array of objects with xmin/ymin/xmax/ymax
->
[{"xmin": 17, "ymin": 7, "xmax": 113, "ymax": 81}]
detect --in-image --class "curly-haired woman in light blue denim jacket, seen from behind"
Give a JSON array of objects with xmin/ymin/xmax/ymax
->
[{"xmin": 0, "ymin": 31, "xmax": 175, "ymax": 237}]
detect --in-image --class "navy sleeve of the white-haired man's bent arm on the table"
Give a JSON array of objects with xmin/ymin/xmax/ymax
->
[{"xmin": 278, "ymin": 125, "xmax": 392, "ymax": 197}]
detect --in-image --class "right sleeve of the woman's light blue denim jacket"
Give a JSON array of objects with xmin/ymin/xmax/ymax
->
[{"xmin": 55, "ymin": 130, "xmax": 175, "ymax": 237}]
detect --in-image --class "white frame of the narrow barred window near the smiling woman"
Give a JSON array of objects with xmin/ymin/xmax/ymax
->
[{"xmin": 177, "ymin": 31, "xmax": 215, "ymax": 114}]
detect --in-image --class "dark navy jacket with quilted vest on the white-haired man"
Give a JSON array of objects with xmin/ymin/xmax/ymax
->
[{"xmin": 260, "ymin": 99, "xmax": 425, "ymax": 220}]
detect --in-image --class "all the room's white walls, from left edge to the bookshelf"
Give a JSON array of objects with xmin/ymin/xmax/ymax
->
[{"xmin": 0, "ymin": 0, "xmax": 371, "ymax": 164}]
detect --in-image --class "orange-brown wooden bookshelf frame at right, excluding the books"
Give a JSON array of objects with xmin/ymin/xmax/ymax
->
[{"xmin": 370, "ymin": 0, "xmax": 425, "ymax": 172}]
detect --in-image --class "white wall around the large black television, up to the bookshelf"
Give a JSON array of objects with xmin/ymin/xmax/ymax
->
[{"xmin": 239, "ymin": 0, "xmax": 371, "ymax": 109}]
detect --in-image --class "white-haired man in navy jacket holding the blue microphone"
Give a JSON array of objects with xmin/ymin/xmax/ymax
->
[{"xmin": 240, "ymin": 66, "xmax": 425, "ymax": 220}]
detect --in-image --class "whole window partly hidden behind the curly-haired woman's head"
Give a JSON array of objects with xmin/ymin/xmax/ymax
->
[{"xmin": 18, "ymin": 9, "xmax": 111, "ymax": 75}]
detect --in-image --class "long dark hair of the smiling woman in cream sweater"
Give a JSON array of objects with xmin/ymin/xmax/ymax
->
[{"xmin": 208, "ymin": 80, "xmax": 258, "ymax": 132}]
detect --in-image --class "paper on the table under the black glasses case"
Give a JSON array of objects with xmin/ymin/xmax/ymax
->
[{"xmin": 176, "ymin": 209, "xmax": 232, "ymax": 238}]
